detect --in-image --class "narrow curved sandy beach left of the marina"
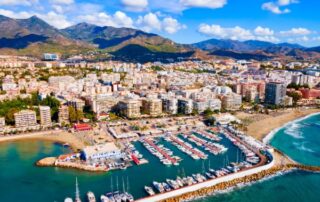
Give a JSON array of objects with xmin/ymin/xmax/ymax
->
[{"xmin": 0, "ymin": 130, "xmax": 86, "ymax": 151}]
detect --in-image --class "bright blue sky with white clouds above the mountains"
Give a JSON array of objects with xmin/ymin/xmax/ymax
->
[{"xmin": 0, "ymin": 0, "xmax": 320, "ymax": 47}]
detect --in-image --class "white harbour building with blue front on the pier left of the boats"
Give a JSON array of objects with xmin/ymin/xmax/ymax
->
[{"xmin": 81, "ymin": 142, "xmax": 122, "ymax": 161}]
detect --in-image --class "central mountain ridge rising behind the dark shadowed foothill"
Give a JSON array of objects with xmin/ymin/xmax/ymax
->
[{"xmin": 62, "ymin": 23, "xmax": 191, "ymax": 52}]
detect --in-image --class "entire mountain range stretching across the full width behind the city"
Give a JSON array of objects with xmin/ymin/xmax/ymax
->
[{"xmin": 0, "ymin": 15, "xmax": 320, "ymax": 62}]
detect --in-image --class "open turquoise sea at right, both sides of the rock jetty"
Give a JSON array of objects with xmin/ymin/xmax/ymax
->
[{"xmin": 198, "ymin": 115, "xmax": 320, "ymax": 202}]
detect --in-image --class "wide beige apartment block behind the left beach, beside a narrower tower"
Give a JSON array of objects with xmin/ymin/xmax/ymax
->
[{"xmin": 14, "ymin": 110, "xmax": 37, "ymax": 128}]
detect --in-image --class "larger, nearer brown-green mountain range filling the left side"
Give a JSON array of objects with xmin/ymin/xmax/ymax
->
[{"xmin": 0, "ymin": 15, "xmax": 198, "ymax": 61}]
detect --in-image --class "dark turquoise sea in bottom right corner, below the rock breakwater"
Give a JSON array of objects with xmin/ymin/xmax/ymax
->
[{"xmin": 198, "ymin": 172, "xmax": 320, "ymax": 202}]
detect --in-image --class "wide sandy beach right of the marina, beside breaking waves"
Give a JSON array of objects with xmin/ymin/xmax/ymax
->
[{"xmin": 236, "ymin": 108, "xmax": 320, "ymax": 141}]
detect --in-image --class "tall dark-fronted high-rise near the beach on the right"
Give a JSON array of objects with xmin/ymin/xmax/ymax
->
[{"xmin": 265, "ymin": 82, "xmax": 287, "ymax": 105}]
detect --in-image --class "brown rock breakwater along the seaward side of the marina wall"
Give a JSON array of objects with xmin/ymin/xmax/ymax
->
[{"xmin": 162, "ymin": 164, "xmax": 320, "ymax": 202}]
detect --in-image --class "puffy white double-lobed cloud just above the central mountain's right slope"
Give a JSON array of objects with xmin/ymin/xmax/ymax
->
[{"xmin": 136, "ymin": 13, "xmax": 186, "ymax": 34}]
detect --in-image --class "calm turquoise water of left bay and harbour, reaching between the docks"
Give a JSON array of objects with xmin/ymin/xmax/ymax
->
[{"xmin": 0, "ymin": 134, "xmax": 241, "ymax": 202}]
